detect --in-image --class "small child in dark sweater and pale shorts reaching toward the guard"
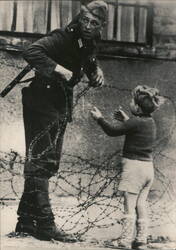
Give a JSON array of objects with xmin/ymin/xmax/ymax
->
[{"xmin": 91, "ymin": 86, "xmax": 160, "ymax": 249}]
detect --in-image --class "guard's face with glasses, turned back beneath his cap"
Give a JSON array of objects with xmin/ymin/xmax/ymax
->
[{"xmin": 79, "ymin": 11, "xmax": 103, "ymax": 40}]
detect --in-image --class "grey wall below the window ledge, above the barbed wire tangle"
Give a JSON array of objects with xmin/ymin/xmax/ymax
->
[{"xmin": 0, "ymin": 52, "xmax": 176, "ymax": 191}]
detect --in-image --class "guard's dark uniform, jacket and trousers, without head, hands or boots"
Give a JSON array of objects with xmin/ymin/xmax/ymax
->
[{"xmin": 18, "ymin": 24, "xmax": 100, "ymax": 221}]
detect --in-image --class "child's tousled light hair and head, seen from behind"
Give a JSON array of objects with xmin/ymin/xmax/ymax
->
[{"xmin": 132, "ymin": 85, "xmax": 160, "ymax": 114}]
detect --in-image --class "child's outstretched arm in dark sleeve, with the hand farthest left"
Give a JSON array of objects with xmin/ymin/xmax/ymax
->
[{"xmin": 91, "ymin": 107, "xmax": 135, "ymax": 136}]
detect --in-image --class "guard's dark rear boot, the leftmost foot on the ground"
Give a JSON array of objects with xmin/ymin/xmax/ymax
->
[{"xmin": 15, "ymin": 217, "xmax": 36, "ymax": 236}]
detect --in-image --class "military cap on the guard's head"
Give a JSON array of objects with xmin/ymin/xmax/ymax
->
[{"xmin": 81, "ymin": 0, "xmax": 108, "ymax": 21}]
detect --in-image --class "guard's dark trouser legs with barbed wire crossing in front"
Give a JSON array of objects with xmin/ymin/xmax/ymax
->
[{"xmin": 17, "ymin": 95, "xmax": 67, "ymax": 223}]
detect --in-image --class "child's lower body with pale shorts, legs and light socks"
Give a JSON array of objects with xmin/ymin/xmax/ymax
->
[{"xmin": 119, "ymin": 158, "xmax": 154, "ymax": 246}]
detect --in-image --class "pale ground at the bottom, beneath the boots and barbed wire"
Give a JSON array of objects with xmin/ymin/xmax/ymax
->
[{"xmin": 1, "ymin": 198, "xmax": 176, "ymax": 250}]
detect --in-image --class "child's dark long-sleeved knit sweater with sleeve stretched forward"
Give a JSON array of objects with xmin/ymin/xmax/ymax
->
[{"xmin": 97, "ymin": 116, "xmax": 156, "ymax": 161}]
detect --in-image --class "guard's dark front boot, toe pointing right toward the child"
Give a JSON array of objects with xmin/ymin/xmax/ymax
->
[{"xmin": 36, "ymin": 223, "xmax": 77, "ymax": 242}]
